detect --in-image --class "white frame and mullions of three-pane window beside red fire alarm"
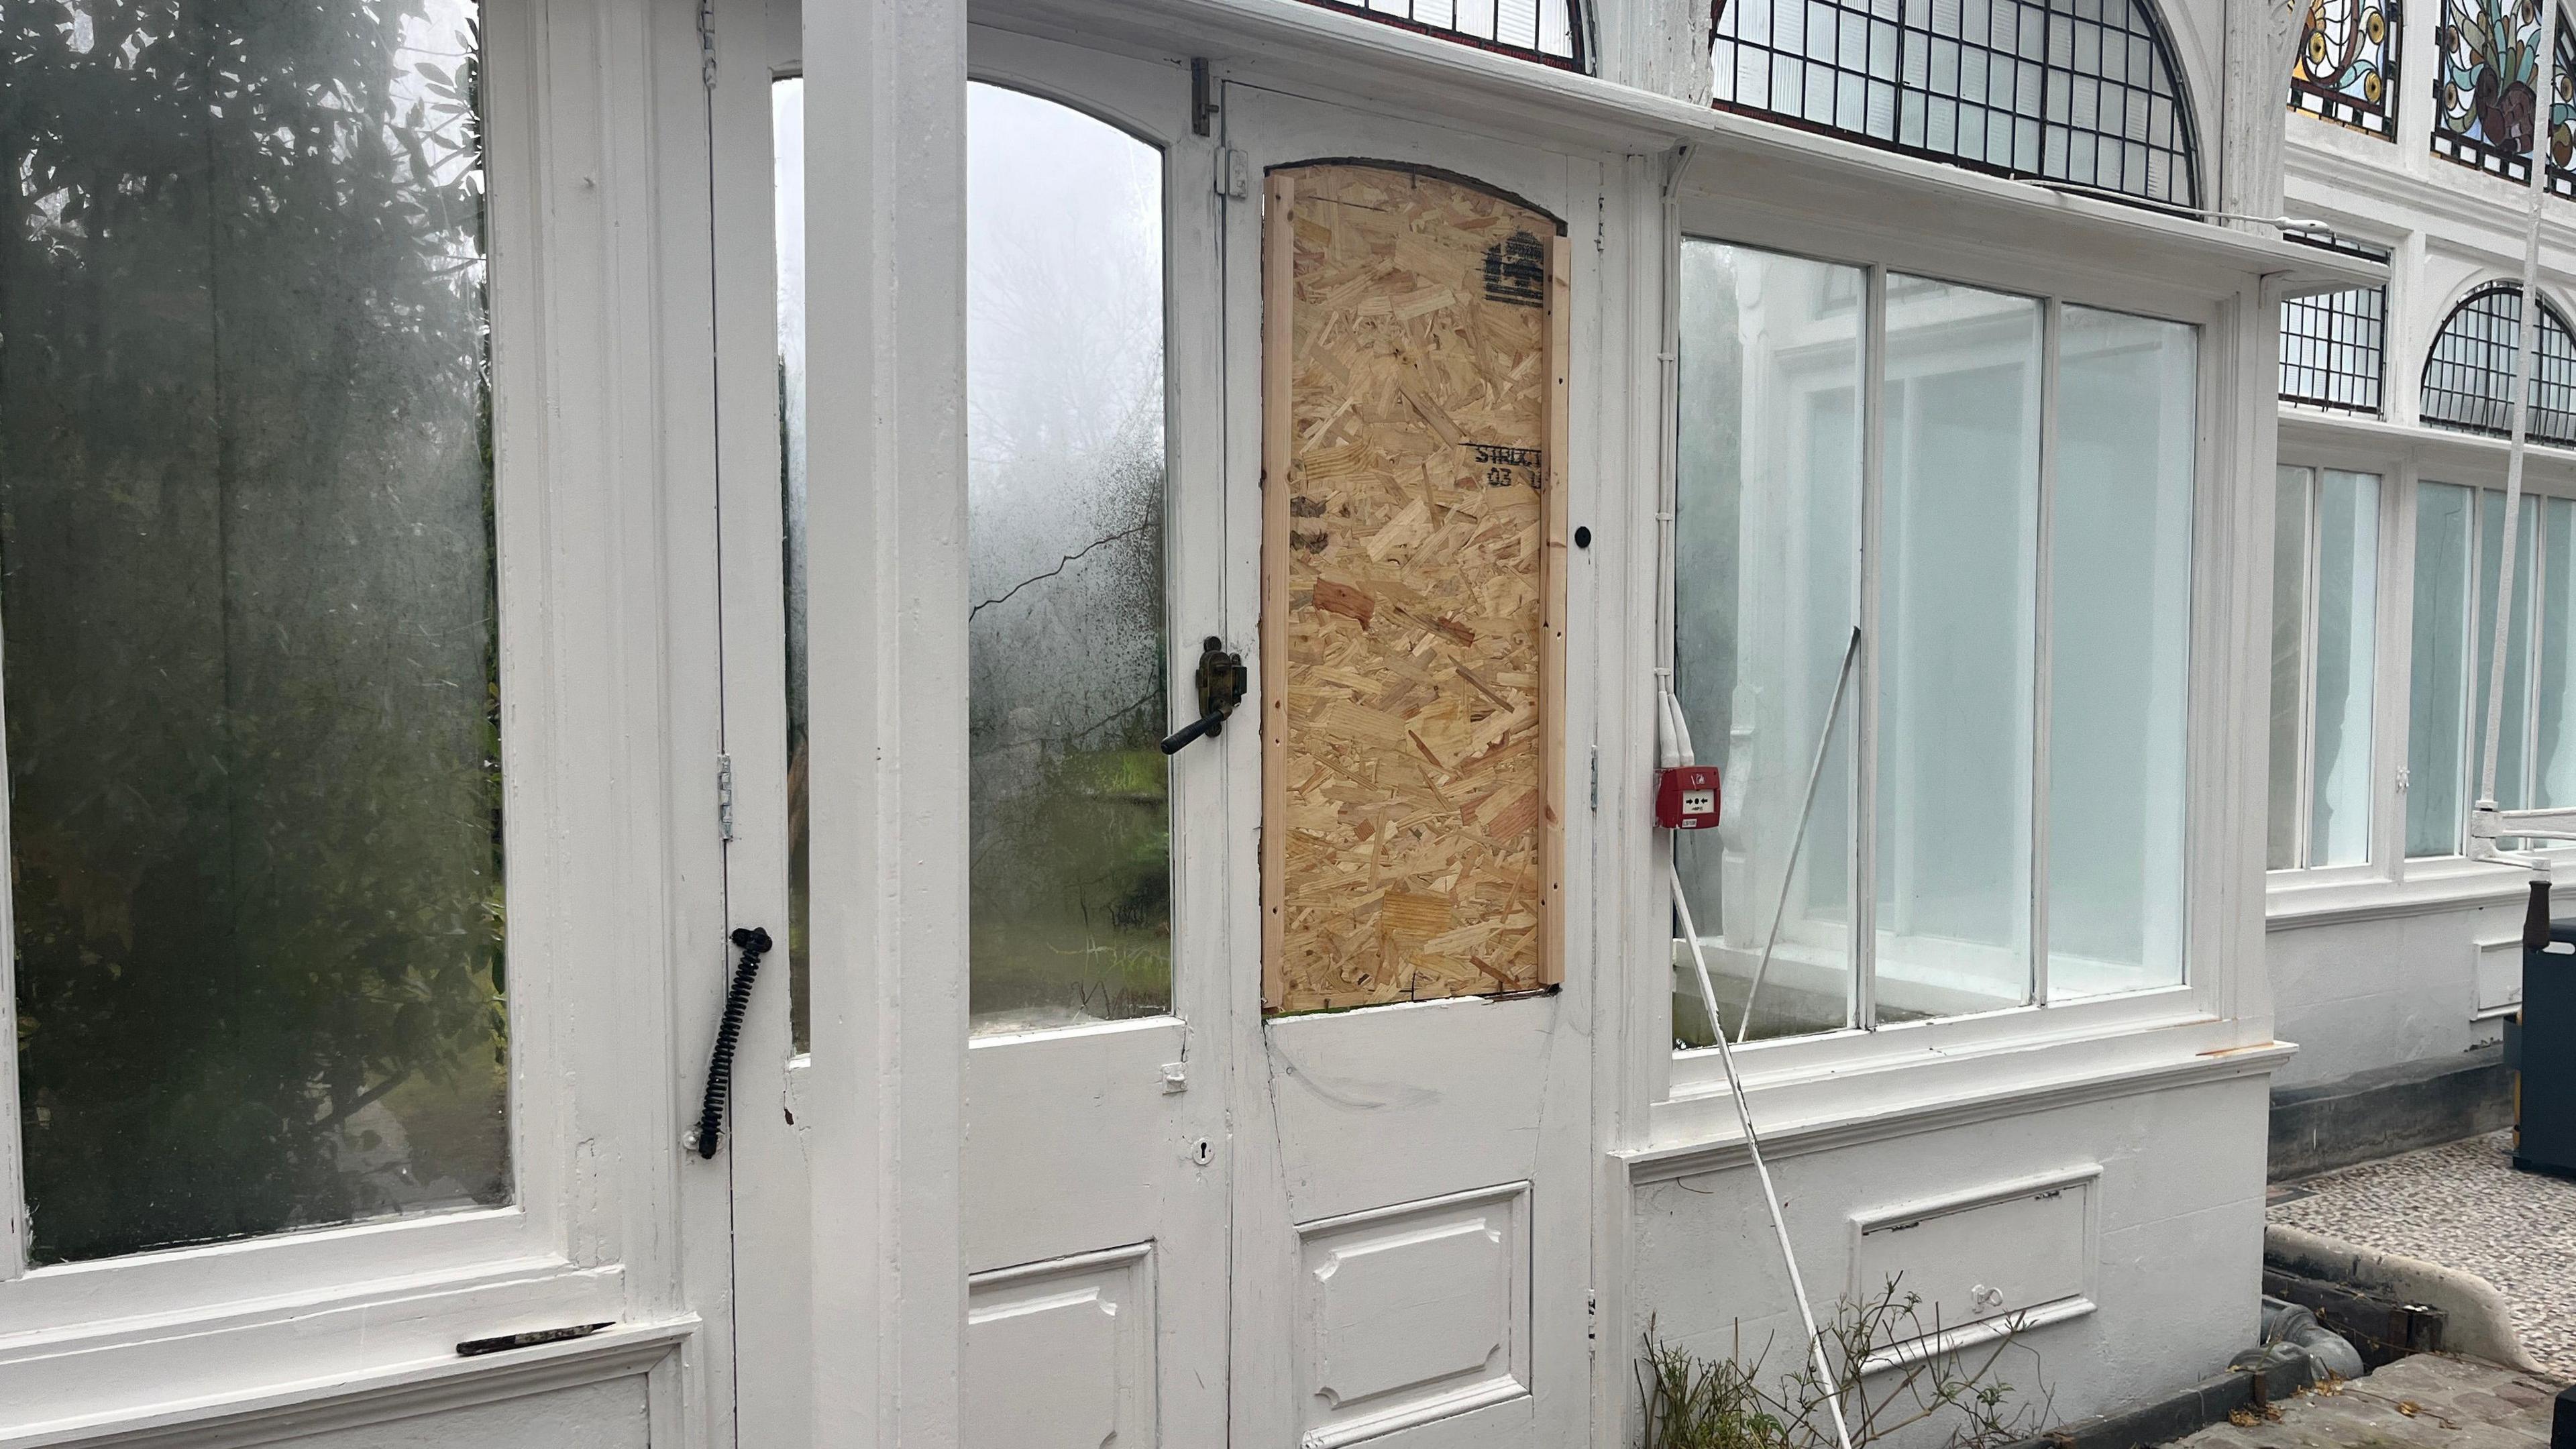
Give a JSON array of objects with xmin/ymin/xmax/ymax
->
[{"xmin": 1631, "ymin": 185, "xmax": 2279, "ymax": 1152}]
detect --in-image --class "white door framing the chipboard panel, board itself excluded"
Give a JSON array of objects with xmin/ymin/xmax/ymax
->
[{"xmin": 1221, "ymin": 85, "xmax": 1602, "ymax": 1449}]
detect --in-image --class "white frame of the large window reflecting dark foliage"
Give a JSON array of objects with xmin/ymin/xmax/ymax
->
[{"xmin": 0, "ymin": 0, "xmax": 727, "ymax": 1444}]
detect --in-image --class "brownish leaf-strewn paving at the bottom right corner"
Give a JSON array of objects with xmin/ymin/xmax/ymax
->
[{"xmin": 2180, "ymin": 1354, "xmax": 2558, "ymax": 1449}]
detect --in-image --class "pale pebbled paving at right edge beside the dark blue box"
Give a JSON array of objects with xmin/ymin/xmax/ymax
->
[{"xmin": 2269, "ymin": 1132, "xmax": 2576, "ymax": 1371}]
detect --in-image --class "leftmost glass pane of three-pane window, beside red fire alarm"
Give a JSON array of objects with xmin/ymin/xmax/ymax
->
[{"xmin": 1674, "ymin": 239, "xmax": 1862, "ymax": 1046}]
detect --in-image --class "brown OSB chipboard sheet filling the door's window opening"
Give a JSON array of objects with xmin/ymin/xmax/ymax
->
[{"xmin": 1263, "ymin": 165, "xmax": 1566, "ymax": 1011}]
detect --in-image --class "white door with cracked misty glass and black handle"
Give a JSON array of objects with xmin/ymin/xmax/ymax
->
[{"xmin": 961, "ymin": 31, "xmax": 1249, "ymax": 1449}]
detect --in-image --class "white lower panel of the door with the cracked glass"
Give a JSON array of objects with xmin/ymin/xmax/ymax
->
[{"xmin": 963, "ymin": 1243, "xmax": 1154, "ymax": 1449}]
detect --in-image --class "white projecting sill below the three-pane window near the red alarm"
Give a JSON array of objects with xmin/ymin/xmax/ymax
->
[{"xmin": 1615, "ymin": 1013, "xmax": 2298, "ymax": 1183}]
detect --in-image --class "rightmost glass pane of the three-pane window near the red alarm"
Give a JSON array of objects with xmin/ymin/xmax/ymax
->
[{"xmin": 2048, "ymin": 307, "xmax": 2200, "ymax": 998}]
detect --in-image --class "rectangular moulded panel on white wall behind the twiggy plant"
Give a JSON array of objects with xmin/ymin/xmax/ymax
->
[{"xmin": 1849, "ymin": 1165, "xmax": 2102, "ymax": 1372}]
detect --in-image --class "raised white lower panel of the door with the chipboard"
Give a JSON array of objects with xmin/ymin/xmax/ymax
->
[{"xmin": 1296, "ymin": 1183, "xmax": 1530, "ymax": 1449}]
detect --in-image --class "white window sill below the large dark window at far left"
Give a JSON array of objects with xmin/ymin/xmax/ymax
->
[{"xmin": 0, "ymin": 1258, "xmax": 629, "ymax": 1449}]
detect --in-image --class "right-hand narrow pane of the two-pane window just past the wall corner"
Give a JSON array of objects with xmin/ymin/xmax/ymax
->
[{"xmin": 2306, "ymin": 470, "xmax": 2380, "ymax": 866}]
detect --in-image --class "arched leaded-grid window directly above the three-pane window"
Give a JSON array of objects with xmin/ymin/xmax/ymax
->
[{"xmin": 1711, "ymin": 0, "xmax": 2200, "ymax": 206}]
